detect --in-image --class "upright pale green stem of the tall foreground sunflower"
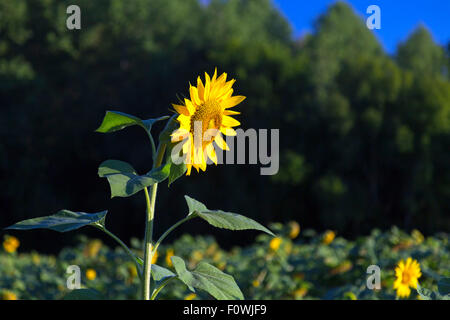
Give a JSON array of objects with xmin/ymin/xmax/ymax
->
[{"xmin": 142, "ymin": 144, "xmax": 166, "ymax": 300}]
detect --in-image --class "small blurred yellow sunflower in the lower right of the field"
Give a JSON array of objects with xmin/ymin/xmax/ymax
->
[{"xmin": 394, "ymin": 258, "xmax": 422, "ymax": 298}]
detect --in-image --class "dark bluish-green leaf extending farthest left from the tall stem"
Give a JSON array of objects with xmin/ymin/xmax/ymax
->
[{"xmin": 6, "ymin": 210, "xmax": 108, "ymax": 232}]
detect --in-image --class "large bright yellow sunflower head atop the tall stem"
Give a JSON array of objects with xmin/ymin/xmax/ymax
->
[{"xmin": 171, "ymin": 69, "xmax": 245, "ymax": 175}]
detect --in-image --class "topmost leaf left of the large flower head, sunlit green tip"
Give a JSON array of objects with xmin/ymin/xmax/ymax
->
[{"xmin": 95, "ymin": 111, "xmax": 169, "ymax": 133}]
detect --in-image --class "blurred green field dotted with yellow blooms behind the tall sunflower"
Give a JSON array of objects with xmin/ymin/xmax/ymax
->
[{"xmin": 0, "ymin": 222, "xmax": 450, "ymax": 300}]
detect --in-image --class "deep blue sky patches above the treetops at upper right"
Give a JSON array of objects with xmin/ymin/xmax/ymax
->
[{"xmin": 273, "ymin": 0, "xmax": 450, "ymax": 53}]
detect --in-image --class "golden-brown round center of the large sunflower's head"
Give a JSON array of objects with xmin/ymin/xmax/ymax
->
[{"xmin": 191, "ymin": 100, "xmax": 222, "ymax": 137}]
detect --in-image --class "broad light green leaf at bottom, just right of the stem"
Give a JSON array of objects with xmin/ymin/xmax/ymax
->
[{"xmin": 172, "ymin": 256, "xmax": 244, "ymax": 300}]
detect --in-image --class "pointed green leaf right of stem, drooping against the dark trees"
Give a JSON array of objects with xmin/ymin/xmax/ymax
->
[{"xmin": 184, "ymin": 196, "xmax": 275, "ymax": 236}]
